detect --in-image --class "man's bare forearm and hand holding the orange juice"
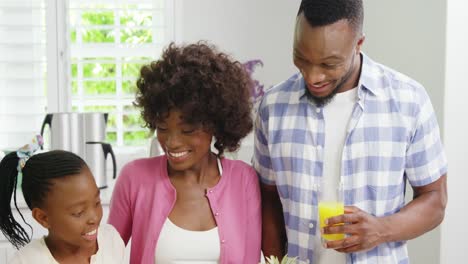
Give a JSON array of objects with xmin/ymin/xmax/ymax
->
[{"xmin": 323, "ymin": 175, "xmax": 447, "ymax": 253}]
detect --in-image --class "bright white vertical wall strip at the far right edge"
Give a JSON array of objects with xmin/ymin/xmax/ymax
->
[{"xmin": 441, "ymin": 0, "xmax": 468, "ymax": 264}]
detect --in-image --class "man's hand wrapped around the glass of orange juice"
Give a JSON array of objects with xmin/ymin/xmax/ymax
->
[{"xmin": 322, "ymin": 206, "xmax": 385, "ymax": 253}]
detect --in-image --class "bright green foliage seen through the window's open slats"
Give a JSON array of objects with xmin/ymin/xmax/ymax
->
[{"xmin": 70, "ymin": 5, "xmax": 154, "ymax": 145}]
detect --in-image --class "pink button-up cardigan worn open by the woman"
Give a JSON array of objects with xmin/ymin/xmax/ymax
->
[{"xmin": 109, "ymin": 155, "xmax": 261, "ymax": 264}]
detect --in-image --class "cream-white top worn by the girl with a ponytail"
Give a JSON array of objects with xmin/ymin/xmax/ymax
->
[{"xmin": 8, "ymin": 224, "xmax": 125, "ymax": 264}]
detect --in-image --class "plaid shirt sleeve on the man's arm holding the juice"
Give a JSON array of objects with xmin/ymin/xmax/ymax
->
[{"xmin": 405, "ymin": 87, "xmax": 447, "ymax": 186}]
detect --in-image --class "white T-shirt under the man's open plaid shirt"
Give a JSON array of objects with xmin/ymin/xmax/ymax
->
[{"xmin": 314, "ymin": 88, "xmax": 357, "ymax": 264}]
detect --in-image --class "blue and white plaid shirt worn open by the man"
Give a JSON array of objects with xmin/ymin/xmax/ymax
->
[{"xmin": 253, "ymin": 54, "xmax": 447, "ymax": 263}]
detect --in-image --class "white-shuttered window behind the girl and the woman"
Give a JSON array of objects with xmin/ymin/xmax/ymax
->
[{"xmin": 0, "ymin": 0, "xmax": 174, "ymax": 152}]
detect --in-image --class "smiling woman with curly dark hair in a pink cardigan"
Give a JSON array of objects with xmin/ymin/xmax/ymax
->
[{"xmin": 109, "ymin": 43, "xmax": 261, "ymax": 264}]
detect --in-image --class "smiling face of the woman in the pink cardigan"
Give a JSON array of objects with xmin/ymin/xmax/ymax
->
[{"xmin": 156, "ymin": 110, "xmax": 213, "ymax": 171}]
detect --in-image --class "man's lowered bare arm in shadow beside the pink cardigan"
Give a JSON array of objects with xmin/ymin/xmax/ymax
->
[{"xmin": 260, "ymin": 183, "xmax": 287, "ymax": 259}]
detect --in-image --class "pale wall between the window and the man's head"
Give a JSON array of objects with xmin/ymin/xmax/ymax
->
[{"xmin": 176, "ymin": 0, "xmax": 300, "ymax": 91}]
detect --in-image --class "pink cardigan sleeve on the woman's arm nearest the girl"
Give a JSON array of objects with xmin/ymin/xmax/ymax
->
[{"xmin": 108, "ymin": 163, "xmax": 133, "ymax": 245}]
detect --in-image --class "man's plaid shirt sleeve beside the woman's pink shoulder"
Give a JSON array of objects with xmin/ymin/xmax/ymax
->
[{"xmin": 252, "ymin": 101, "xmax": 276, "ymax": 185}]
